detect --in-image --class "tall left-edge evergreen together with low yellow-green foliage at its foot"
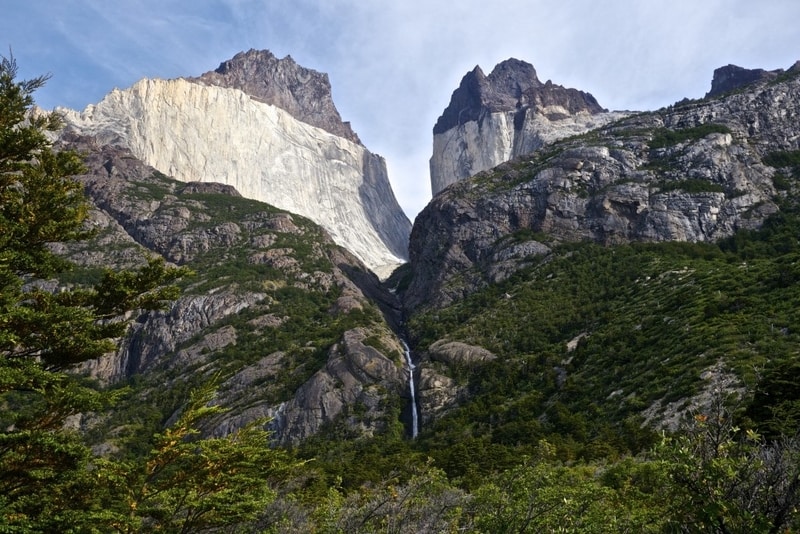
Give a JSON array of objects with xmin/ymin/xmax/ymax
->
[{"xmin": 0, "ymin": 57, "xmax": 289, "ymax": 532}]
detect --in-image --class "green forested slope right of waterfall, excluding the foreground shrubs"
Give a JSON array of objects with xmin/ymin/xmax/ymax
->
[{"xmin": 409, "ymin": 206, "xmax": 800, "ymax": 466}]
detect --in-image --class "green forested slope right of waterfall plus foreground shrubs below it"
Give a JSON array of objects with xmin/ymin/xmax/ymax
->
[{"xmin": 286, "ymin": 195, "xmax": 800, "ymax": 532}]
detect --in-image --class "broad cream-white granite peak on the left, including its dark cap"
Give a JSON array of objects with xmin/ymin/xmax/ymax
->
[{"xmin": 61, "ymin": 51, "xmax": 410, "ymax": 274}]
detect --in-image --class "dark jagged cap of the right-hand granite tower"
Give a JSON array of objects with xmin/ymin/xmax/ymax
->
[{"xmin": 433, "ymin": 58, "xmax": 605, "ymax": 135}]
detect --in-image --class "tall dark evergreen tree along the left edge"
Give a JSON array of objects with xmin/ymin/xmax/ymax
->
[{"xmin": 0, "ymin": 57, "xmax": 186, "ymax": 531}]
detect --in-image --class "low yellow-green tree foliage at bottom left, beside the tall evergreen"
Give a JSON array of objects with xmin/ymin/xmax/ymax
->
[{"xmin": 87, "ymin": 386, "xmax": 297, "ymax": 533}]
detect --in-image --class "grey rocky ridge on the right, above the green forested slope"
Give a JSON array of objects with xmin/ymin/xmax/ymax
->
[{"xmin": 406, "ymin": 66, "xmax": 800, "ymax": 309}]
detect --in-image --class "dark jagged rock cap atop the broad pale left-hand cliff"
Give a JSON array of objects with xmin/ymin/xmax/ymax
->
[{"xmin": 188, "ymin": 49, "xmax": 360, "ymax": 143}]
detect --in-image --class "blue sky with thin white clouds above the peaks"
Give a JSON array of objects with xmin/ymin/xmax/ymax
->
[{"xmin": 0, "ymin": 0, "xmax": 800, "ymax": 221}]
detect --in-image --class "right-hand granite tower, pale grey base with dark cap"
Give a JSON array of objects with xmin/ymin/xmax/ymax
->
[{"xmin": 430, "ymin": 59, "xmax": 624, "ymax": 196}]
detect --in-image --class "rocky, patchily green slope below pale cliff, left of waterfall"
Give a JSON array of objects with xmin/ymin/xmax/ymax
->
[{"xmin": 60, "ymin": 136, "xmax": 408, "ymax": 447}]
